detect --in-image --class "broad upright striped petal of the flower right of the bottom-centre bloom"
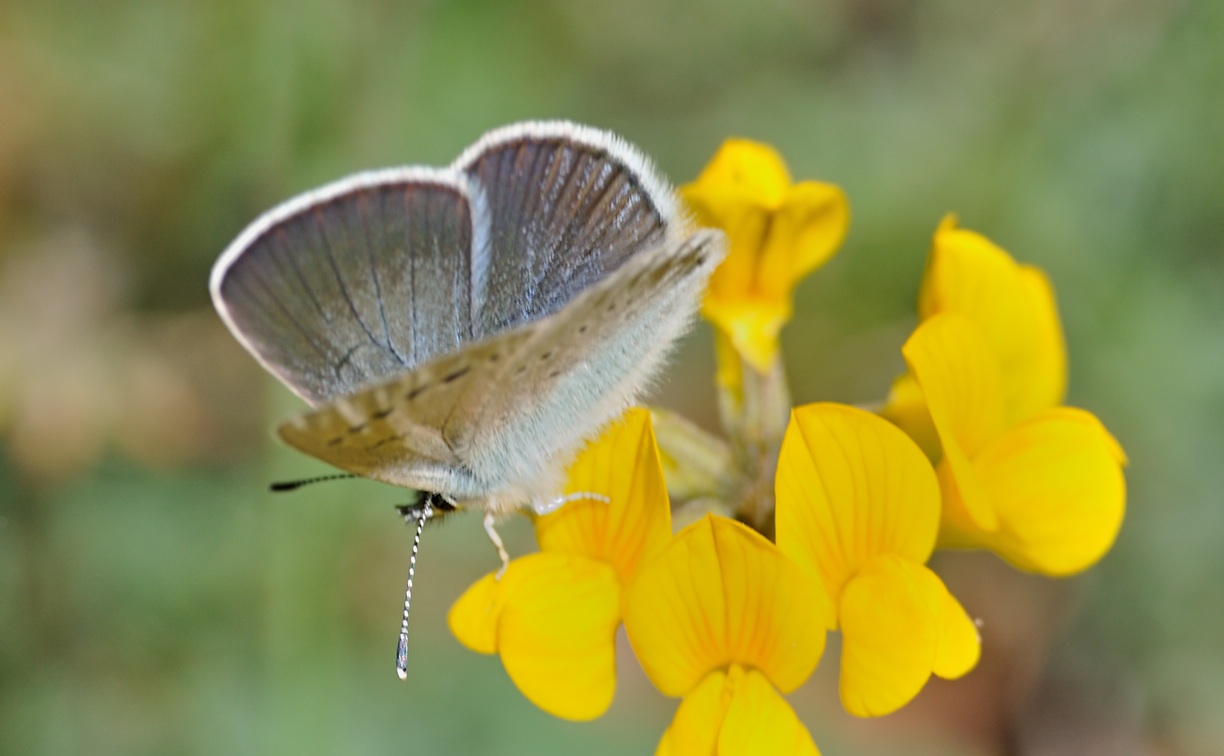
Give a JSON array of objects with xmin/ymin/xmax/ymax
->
[{"xmin": 776, "ymin": 404, "xmax": 940, "ymax": 602}]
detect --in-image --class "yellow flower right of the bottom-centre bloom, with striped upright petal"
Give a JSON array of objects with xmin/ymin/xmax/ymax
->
[{"xmin": 777, "ymin": 404, "xmax": 980, "ymax": 717}]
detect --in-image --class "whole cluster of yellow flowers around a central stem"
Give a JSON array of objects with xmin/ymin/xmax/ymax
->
[{"xmin": 449, "ymin": 139, "xmax": 1126, "ymax": 755}]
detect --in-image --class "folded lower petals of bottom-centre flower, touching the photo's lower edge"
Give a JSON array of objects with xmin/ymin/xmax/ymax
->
[{"xmin": 655, "ymin": 664, "xmax": 819, "ymax": 756}]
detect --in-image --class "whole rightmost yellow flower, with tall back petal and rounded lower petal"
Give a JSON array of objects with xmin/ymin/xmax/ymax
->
[{"xmin": 881, "ymin": 215, "xmax": 1126, "ymax": 575}]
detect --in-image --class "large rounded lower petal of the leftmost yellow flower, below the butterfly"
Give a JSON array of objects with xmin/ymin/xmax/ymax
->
[{"xmin": 497, "ymin": 553, "xmax": 621, "ymax": 721}]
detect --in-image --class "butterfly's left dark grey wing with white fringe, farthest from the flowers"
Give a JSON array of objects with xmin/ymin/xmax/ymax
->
[{"xmin": 212, "ymin": 169, "xmax": 480, "ymax": 406}]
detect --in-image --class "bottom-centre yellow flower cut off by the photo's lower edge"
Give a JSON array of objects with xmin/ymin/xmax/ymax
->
[{"xmin": 624, "ymin": 515, "xmax": 830, "ymax": 756}]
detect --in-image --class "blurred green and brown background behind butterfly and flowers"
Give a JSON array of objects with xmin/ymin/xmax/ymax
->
[{"xmin": 0, "ymin": 0, "xmax": 1224, "ymax": 756}]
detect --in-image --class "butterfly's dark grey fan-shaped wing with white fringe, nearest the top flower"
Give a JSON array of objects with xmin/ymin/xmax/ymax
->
[{"xmin": 454, "ymin": 122, "xmax": 678, "ymax": 335}]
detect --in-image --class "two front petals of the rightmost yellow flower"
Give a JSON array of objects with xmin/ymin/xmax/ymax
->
[{"xmin": 902, "ymin": 313, "xmax": 1126, "ymax": 576}]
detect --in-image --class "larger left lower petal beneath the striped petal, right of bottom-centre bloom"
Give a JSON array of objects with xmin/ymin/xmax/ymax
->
[{"xmin": 838, "ymin": 555, "xmax": 940, "ymax": 717}]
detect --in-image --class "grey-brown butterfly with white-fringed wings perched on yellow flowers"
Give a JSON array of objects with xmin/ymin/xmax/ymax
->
[{"xmin": 211, "ymin": 122, "xmax": 725, "ymax": 675}]
